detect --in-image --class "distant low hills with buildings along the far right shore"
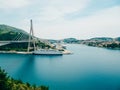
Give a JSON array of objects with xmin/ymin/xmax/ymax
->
[{"xmin": 63, "ymin": 37, "xmax": 120, "ymax": 50}]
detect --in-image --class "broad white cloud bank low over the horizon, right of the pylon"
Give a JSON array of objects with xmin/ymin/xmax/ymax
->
[{"xmin": 32, "ymin": 6, "xmax": 120, "ymax": 39}]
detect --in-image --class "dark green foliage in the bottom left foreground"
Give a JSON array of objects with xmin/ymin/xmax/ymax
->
[{"xmin": 0, "ymin": 68, "xmax": 48, "ymax": 90}]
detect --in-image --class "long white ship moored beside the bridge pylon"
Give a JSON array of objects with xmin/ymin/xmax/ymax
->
[{"xmin": 33, "ymin": 49, "xmax": 63, "ymax": 55}]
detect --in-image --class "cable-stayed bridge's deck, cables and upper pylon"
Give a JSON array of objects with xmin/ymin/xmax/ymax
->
[{"xmin": 0, "ymin": 20, "xmax": 50, "ymax": 48}]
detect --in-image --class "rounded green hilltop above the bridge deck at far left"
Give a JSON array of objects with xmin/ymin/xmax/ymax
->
[{"xmin": 0, "ymin": 24, "xmax": 28, "ymax": 41}]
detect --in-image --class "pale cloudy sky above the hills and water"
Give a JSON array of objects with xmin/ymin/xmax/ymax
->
[{"xmin": 0, "ymin": 0, "xmax": 120, "ymax": 39}]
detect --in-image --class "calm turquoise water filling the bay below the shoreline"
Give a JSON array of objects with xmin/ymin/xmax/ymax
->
[{"xmin": 0, "ymin": 44, "xmax": 120, "ymax": 90}]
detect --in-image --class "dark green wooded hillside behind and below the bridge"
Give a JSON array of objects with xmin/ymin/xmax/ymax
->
[{"xmin": 0, "ymin": 25, "xmax": 50, "ymax": 51}]
